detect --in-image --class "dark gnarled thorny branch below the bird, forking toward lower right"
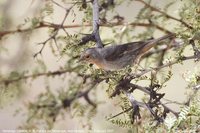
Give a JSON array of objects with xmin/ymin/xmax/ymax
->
[{"xmin": 108, "ymin": 56, "xmax": 197, "ymax": 122}]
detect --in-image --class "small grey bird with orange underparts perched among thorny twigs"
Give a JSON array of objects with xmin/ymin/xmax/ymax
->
[{"xmin": 79, "ymin": 34, "xmax": 174, "ymax": 71}]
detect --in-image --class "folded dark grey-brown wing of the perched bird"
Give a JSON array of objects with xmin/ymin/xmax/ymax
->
[{"xmin": 101, "ymin": 41, "xmax": 149, "ymax": 61}]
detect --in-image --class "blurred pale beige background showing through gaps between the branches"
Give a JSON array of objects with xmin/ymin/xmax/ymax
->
[{"xmin": 0, "ymin": 0, "xmax": 198, "ymax": 131}]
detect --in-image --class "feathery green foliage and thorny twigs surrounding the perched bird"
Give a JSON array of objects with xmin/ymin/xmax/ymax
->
[{"xmin": 0, "ymin": 0, "xmax": 200, "ymax": 132}]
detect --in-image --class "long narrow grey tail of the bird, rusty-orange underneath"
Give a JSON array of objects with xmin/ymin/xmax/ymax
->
[{"xmin": 141, "ymin": 34, "xmax": 175, "ymax": 54}]
